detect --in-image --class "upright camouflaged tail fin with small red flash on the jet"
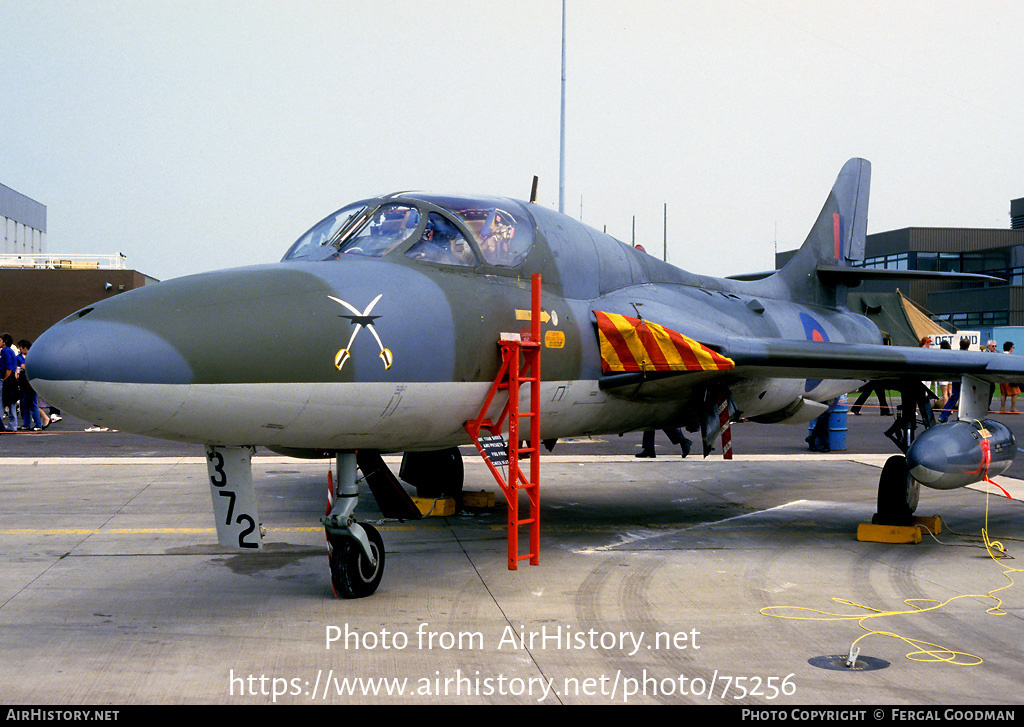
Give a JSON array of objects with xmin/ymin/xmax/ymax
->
[{"xmin": 769, "ymin": 159, "xmax": 871, "ymax": 306}]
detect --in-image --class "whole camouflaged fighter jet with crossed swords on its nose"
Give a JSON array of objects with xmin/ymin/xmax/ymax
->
[{"xmin": 29, "ymin": 159, "xmax": 1024, "ymax": 597}]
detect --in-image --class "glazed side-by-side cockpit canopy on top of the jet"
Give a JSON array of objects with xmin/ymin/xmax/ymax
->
[{"xmin": 284, "ymin": 195, "xmax": 535, "ymax": 267}]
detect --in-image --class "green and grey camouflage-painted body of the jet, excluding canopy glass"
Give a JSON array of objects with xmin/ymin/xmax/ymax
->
[{"xmin": 28, "ymin": 160, "xmax": 1024, "ymax": 452}]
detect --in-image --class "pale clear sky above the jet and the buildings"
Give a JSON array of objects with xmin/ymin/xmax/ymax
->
[{"xmin": 0, "ymin": 0, "xmax": 1024, "ymax": 279}]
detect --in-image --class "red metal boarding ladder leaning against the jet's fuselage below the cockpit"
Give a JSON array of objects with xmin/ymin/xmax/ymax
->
[{"xmin": 465, "ymin": 273, "xmax": 541, "ymax": 570}]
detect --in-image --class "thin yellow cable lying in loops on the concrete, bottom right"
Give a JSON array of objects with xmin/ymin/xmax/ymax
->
[{"xmin": 760, "ymin": 487, "xmax": 1024, "ymax": 667}]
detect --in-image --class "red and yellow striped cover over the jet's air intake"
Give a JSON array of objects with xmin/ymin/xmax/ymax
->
[{"xmin": 594, "ymin": 310, "xmax": 735, "ymax": 374}]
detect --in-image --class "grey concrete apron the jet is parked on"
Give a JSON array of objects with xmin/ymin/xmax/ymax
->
[{"xmin": 0, "ymin": 410, "xmax": 1024, "ymax": 715}]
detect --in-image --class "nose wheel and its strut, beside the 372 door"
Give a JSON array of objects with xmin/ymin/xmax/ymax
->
[{"xmin": 321, "ymin": 453, "xmax": 384, "ymax": 598}]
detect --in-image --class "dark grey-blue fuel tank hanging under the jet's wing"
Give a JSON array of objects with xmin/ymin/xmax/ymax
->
[{"xmin": 906, "ymin": 419, "xmax": 1017, "ymax": 489}]
